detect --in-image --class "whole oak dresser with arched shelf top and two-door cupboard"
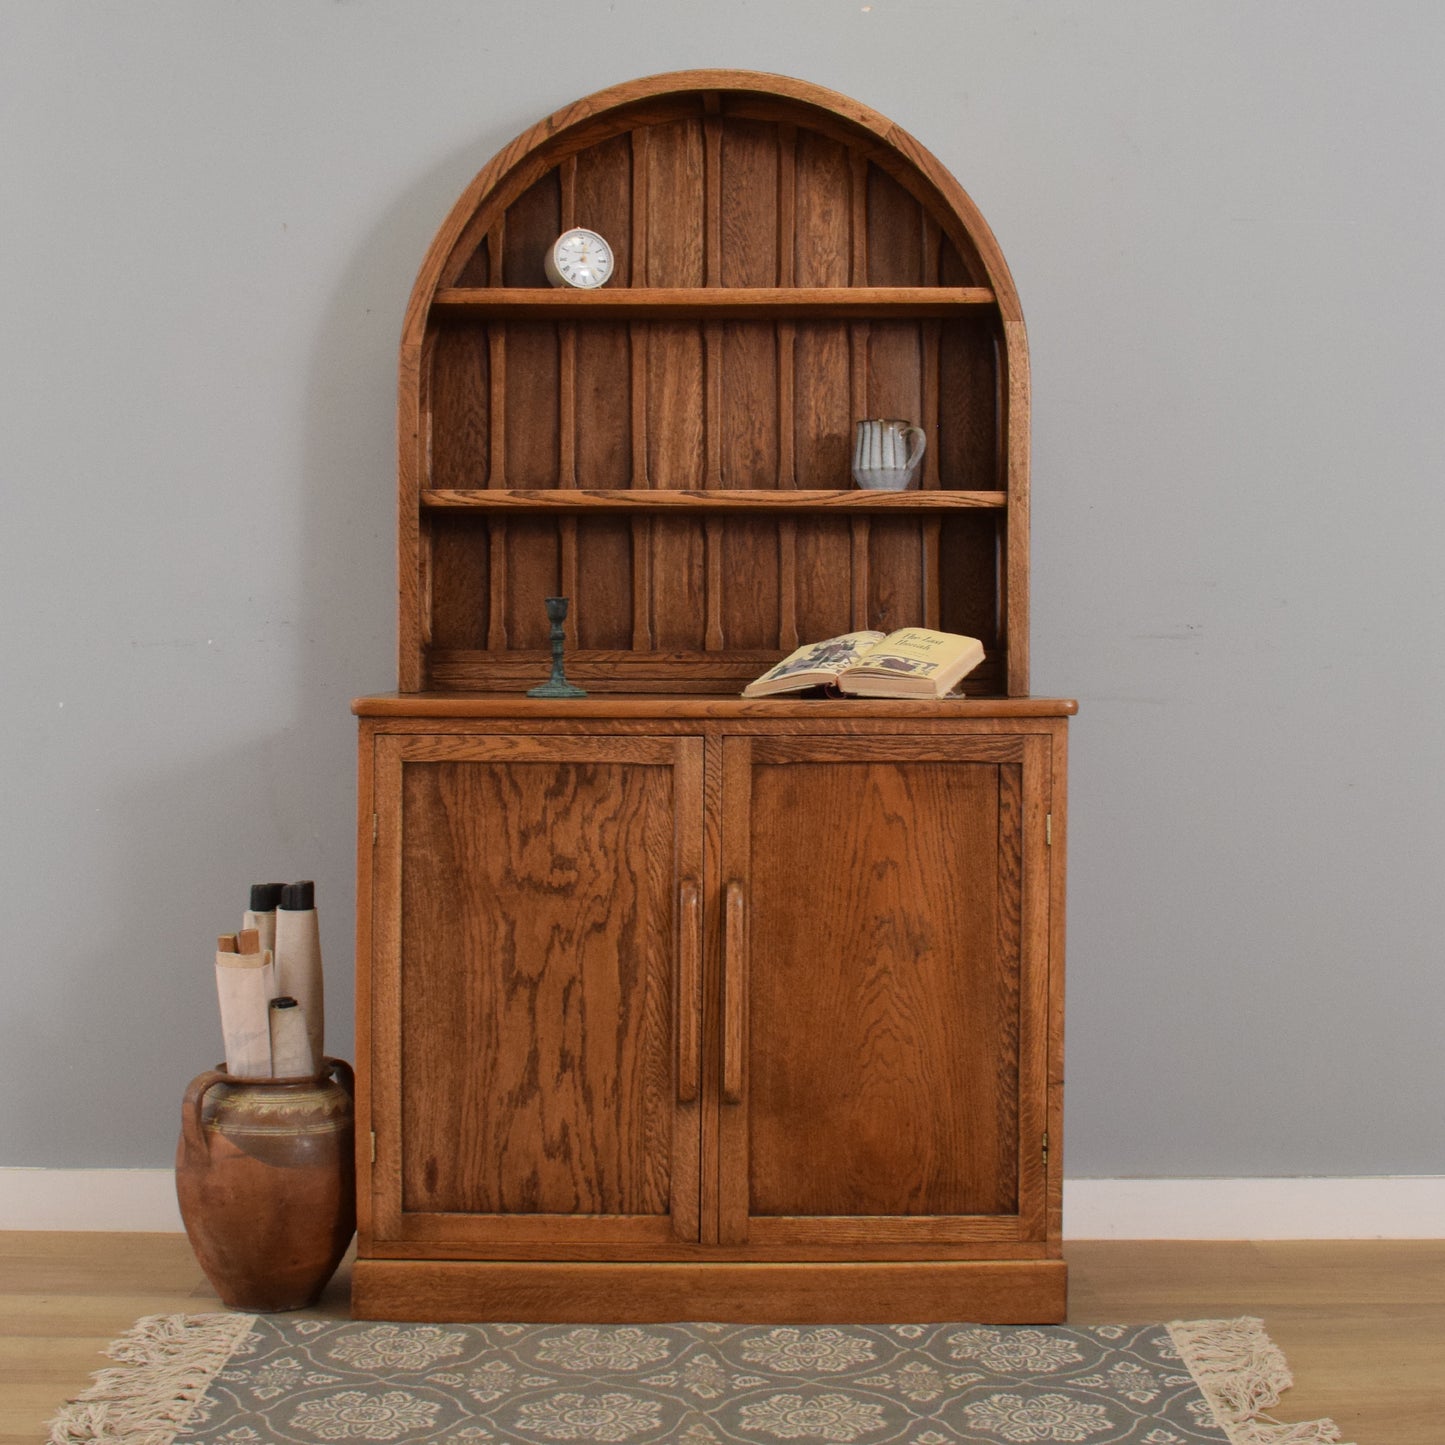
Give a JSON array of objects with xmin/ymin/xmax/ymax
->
[{"xmin": 353, "ymin": 71, "xmax": 1074, "ymax": 1322}]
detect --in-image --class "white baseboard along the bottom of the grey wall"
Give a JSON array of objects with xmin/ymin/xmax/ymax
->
[{"xmin": 0, "ymin": 1168, "xmax": 1445, "ymax": 1240}]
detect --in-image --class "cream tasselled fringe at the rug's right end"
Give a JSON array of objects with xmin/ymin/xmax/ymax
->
[{"xmin": 1165, "ymin": 1316, "xmax": 1340, "ymax": 1445}]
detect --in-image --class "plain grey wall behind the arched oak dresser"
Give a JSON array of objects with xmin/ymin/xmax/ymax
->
[{"xmin": 0, "ymin": 0, "xmax": 1445, "ymax": 1175}]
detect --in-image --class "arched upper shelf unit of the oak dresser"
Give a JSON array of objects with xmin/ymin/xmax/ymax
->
[{"xmin": 399, "ymin": 71, "xmax": 1029, "ymax": 696}]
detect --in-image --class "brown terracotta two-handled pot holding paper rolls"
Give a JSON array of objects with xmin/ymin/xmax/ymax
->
[{"xmin": 176, "ymin": 1059, "xmax": 355, "ymax": 1312}]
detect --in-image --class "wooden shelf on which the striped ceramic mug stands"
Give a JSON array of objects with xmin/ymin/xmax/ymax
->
[{"xmin": 422, "ymin": 487, "xmax": 1009, "ymax": 513}]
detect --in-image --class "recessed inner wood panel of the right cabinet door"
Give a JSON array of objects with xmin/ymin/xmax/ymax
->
[{"xmin": 747, "ymin": 751, "xmax": 1022, "ymax": 1215}]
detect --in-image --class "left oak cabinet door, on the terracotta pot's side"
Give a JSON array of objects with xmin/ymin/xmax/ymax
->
[{"xmin": 373, "ymin": 736, "xmax": 702, "ymax": 1257}]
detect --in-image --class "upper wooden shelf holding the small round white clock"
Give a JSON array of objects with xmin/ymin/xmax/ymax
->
[{"xmin": 432, "ymin": 286, "xmax": 997, "ymax": 321}]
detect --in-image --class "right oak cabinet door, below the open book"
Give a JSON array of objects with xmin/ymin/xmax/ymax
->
[{"xmin": 718, "ymin": 734, "xmax": 1049, "ymax": 1253}]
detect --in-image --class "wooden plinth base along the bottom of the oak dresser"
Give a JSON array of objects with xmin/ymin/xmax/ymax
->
[{"xmin": 351, "ymin": 1260, "xmax": 1068, "ymax": 1325}]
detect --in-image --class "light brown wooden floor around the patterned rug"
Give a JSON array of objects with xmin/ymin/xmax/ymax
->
[{"xmin": 0, "ymin": 1233, "xmax": 1445, "ymax": 1445}]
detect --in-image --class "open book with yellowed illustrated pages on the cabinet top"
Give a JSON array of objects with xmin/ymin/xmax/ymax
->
[{"xmin": 743, "ymin": 627, "xmax": 984, "ymax": 698}]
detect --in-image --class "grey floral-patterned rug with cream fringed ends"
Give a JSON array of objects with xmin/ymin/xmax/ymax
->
[{"xmin": 51, "ymin": 1315, "xmax": 1340, "ymax": 1445}]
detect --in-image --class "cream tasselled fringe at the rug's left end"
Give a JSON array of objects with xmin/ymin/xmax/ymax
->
[{"xmin": 49, "ymin": 1314, "xmax": 256, "ymax": 1445}]
